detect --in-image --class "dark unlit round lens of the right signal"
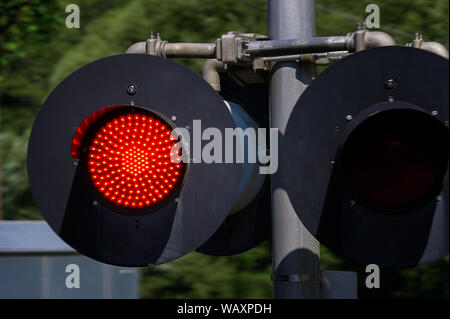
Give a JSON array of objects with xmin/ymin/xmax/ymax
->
[{"xmin": 342, "ymin": 109, "xmax": 449, "ymax": 209}]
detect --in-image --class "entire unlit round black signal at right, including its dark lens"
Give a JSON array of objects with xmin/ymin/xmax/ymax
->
[{"xmin": 280, "ymin": 46, "xmax": 449, "ymax": 268}]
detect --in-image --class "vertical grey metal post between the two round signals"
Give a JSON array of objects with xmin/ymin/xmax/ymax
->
[{"xmin": 268, "ymin": 0, "xmax": 320, "ymax": 298}]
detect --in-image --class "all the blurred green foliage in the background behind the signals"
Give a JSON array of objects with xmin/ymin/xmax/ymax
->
[{"xmin": 0, "ymin": 0, "xmax": 449, "ymax": 298}]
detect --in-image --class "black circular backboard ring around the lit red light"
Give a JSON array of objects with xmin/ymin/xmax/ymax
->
[{"xmin": 28, "ymin": 54, "xmax": 240, "ymax": 266}]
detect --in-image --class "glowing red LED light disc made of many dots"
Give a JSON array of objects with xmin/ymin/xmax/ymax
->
[{"xmin": 87, "ymin": 114, "xmax": 184, "ymax": 208}]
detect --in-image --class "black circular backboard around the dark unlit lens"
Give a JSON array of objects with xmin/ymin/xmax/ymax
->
[{"xmin": 280, "ymin": 46, "xmax": 449, "ymax": 268}]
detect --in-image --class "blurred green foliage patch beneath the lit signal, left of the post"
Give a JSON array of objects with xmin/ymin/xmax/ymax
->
[{"xmin": 141, "ymin": 242, "xmax": 272, "ymax": 298}]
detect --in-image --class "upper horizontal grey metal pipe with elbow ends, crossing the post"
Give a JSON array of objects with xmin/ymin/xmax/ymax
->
[{"xmin": 126, "ymin": 30, "xmax": 395, "ymax": 63}]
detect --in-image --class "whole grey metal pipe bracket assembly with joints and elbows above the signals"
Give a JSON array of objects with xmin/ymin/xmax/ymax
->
[{"xmin": 126, "ymin": 25, "xmax": 449, "ymax": 91}]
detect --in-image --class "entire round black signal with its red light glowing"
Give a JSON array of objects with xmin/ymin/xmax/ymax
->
[{"xmin": 28, "ymin": 54, "xmax": 268, "ymax": 266}]
